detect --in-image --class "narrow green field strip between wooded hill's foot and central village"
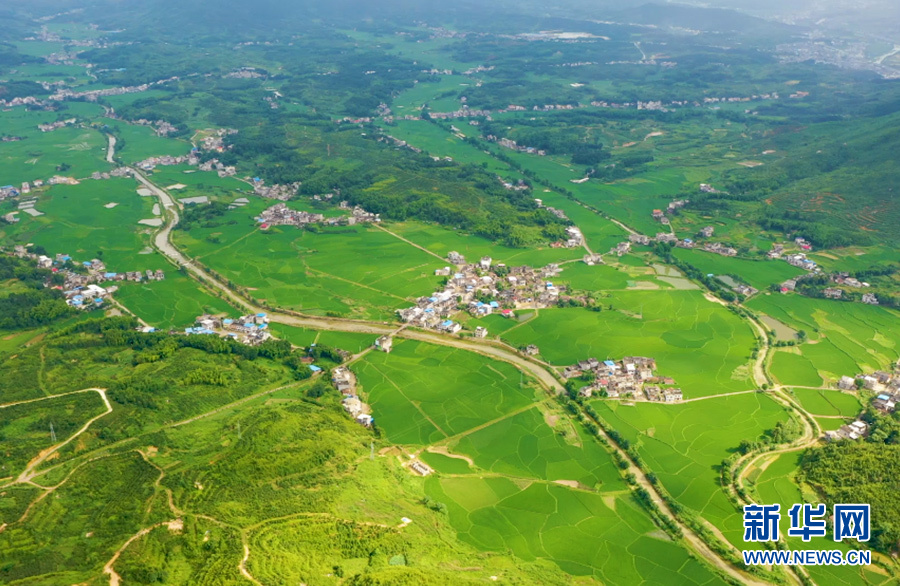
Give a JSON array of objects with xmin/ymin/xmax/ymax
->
[{"xmin": 385, "ymin": 222, "xmax": 584, "ymax": 267}]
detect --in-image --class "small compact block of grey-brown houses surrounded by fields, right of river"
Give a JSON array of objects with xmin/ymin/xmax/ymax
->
[{"xmin": 563, "ymin": 356, "xmax": 684, "ymax": 403}]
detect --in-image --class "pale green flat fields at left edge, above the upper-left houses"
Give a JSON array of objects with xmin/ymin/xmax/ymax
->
[{"xmin": 0, "ymin": 106, "xmax": 110, "ymax": 186}]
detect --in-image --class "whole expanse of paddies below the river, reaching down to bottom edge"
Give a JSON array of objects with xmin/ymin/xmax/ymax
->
[{"xmin": 355, "ymin": 341, "xmax": 720, "ymax": 584}]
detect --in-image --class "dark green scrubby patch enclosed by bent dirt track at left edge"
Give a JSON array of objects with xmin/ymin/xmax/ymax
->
[{"xmin": 0, "ymin": 393, "xmax": 106, "ymax": 477}]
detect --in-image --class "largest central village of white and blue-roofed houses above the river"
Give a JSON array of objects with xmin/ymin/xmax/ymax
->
[{"xmin": 398, "ymin": 252, "xmax": 565, "ymax": 330}]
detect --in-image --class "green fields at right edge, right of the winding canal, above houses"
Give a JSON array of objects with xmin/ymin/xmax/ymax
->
[{"xmin": 748, "ymin": 295, "xmax": 900, "ymax": 378}]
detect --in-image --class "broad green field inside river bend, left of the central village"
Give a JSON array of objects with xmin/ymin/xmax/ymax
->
[{"xmin": 176, "ymin": 219, "xmax": 445, "ymax": 320}]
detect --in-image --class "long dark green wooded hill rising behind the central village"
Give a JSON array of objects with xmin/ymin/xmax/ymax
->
[{"xmin": 231, "ymin": 120, "xmax": 566, "ymax": 247}]
